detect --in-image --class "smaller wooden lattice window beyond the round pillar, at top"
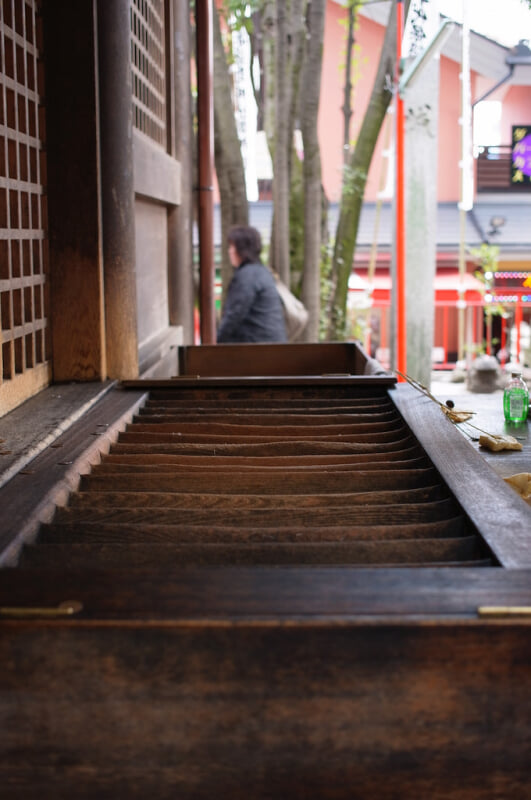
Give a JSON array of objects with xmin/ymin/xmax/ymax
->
[{"xmin": 131, "ymin": 0, "xmax": 166, "ymax": 148}]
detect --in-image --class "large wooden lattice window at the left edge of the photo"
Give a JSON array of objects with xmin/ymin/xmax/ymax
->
[{"xmin": 0, "ymin": 0, "xmax": 48, "ymax": 406}]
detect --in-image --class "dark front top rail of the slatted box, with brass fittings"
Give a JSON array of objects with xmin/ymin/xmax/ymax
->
[{"xmin": 0, "ymin": 565, "xmax": 531, "ymax": 620}]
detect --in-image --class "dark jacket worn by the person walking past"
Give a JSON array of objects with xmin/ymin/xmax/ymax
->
[{"xmin": 218, "ymin": 262, "xmax": 287, "ymax": 342}]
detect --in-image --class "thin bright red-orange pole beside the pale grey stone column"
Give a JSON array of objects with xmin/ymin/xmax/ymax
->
[{"xmin": 395, "ymin": 0, "xmax": 407, "ymax": 380}]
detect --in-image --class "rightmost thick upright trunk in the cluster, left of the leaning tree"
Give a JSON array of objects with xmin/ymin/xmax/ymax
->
[{"xmin": 301, "ymin": 0, "xmax": 326, "ymax": 342}]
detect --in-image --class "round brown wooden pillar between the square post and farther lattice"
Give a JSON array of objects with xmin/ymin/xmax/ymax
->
[{"xmin": 97, "ymin": 0, "xmax": 138, "ymax": 378}]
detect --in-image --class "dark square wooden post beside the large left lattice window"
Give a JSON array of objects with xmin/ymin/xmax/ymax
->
[{"xmin": 43, "ymin": 0, "xmax": 106, "ymax": 382}]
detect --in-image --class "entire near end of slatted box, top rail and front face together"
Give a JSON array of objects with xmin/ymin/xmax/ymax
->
[{"xmin": 0, "ymin": 568, "xmax": 531, "ymax": 800}]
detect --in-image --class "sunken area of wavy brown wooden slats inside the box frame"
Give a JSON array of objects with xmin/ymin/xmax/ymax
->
[{"xmin": 21, "ymin": 385, "xmax": 492, "ymax": 566}]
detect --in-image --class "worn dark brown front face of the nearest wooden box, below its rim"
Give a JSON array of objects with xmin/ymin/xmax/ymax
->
[{"xmin": 0, "ymin": 626, "xmax": 531, "ymax": 800}]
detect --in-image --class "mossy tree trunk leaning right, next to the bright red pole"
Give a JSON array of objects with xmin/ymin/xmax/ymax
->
[{"xmin": 328, "ymin": 0, "xmax": 409, "ymax": 339}]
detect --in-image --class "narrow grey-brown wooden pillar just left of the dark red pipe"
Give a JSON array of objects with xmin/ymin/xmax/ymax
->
[{"xmin": 166, "ymin": 0, "xmax": 194, "ymax": 344}]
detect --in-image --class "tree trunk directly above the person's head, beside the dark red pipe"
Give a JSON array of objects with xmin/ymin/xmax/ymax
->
[{"xmin": 212, "ymin": 0, "xmax": 249, "ymax": 294}]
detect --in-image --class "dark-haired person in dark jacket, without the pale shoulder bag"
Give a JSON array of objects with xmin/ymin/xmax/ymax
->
[{"xmin": 217, "ymin": 225, "xmax": 287, "ymax": 343}]
